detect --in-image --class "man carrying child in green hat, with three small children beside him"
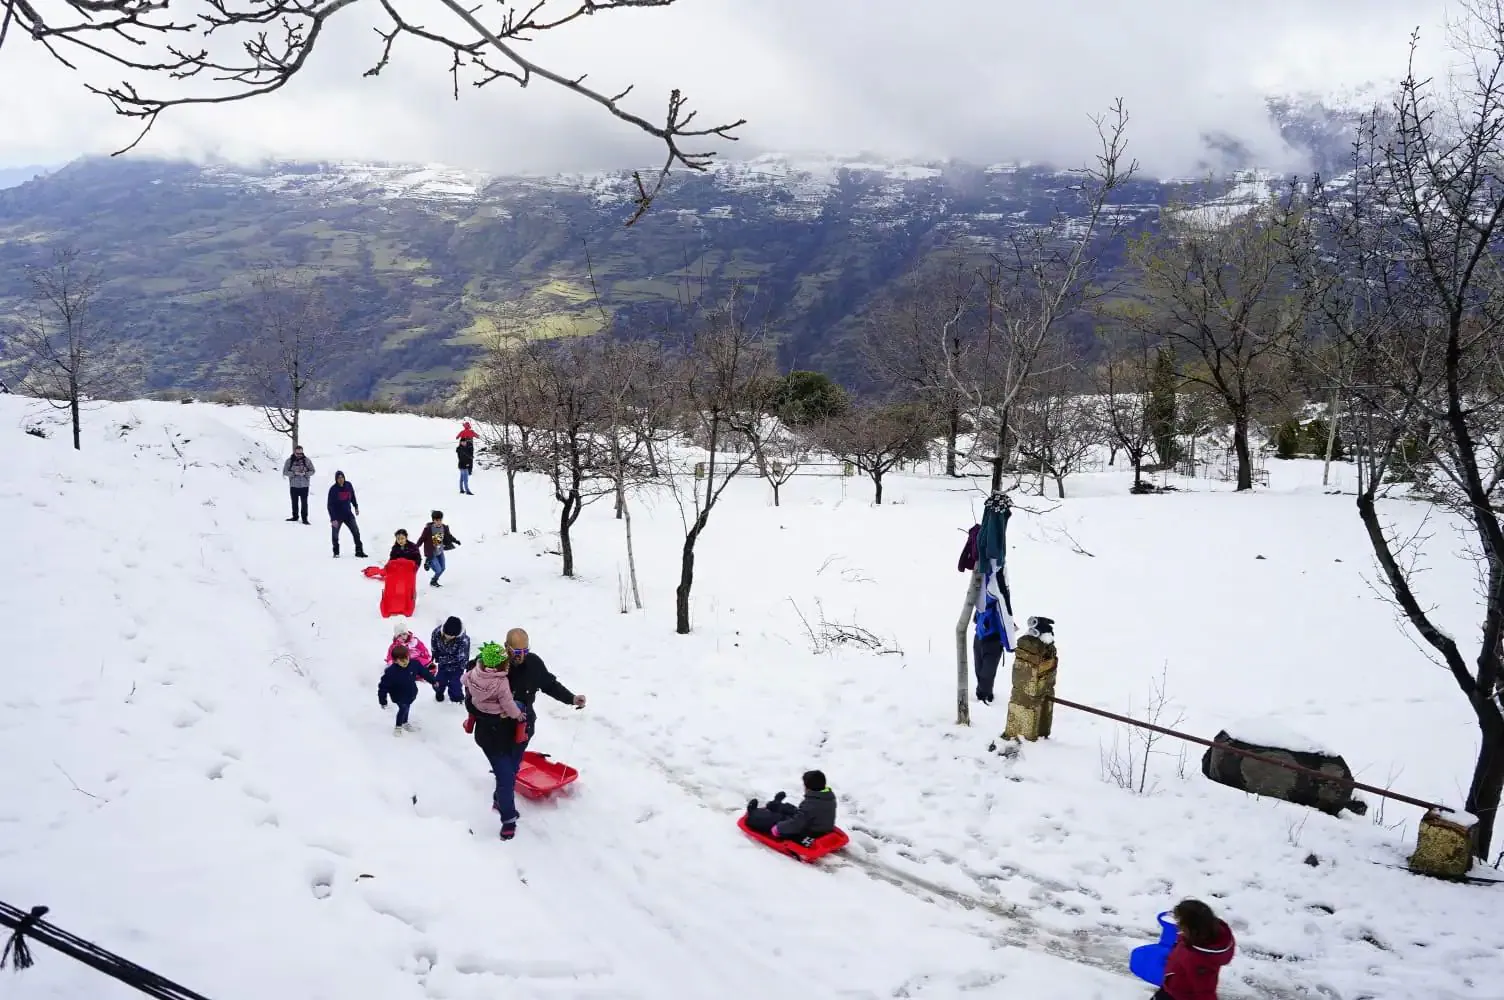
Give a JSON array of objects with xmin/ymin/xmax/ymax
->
[{"xmin": 376, "ymin": 617, "xmax": 585, "ymax": 841}]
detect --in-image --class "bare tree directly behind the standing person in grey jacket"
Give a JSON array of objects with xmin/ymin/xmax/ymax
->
[{"xmin": 239, "ymin": 271, "xmax": 356, "ymax": 448}]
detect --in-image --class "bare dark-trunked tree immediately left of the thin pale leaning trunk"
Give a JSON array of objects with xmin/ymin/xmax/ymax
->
[{"xmin": 516, "ymin": 340, "xmax": 615, "ymax": 576}]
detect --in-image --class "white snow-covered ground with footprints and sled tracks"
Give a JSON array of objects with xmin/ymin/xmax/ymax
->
[{"xmin": 0, "ymin": 397, "xmax": 1504, "ymax": 1000}]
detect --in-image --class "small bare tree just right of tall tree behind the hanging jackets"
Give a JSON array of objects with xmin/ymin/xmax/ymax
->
[{"xmin": 1014, "ymin": 338, "xmax": 1105, "ymax": 499}]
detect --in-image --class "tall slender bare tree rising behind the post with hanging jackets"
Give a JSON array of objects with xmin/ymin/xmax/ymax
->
[{"xmin": 956, "ymin": 101, "xmax": 1139, "ymax": 490}]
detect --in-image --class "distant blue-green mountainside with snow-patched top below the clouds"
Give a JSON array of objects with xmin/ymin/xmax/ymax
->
[{"xmin": 0, "ymin": 101, "xmax": 1371, "ymax": 398}]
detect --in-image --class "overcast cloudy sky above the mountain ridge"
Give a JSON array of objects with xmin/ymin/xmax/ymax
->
[{"xmin": 0, "ymin": 0, "xmax": 1448, "ymax": 174}]
